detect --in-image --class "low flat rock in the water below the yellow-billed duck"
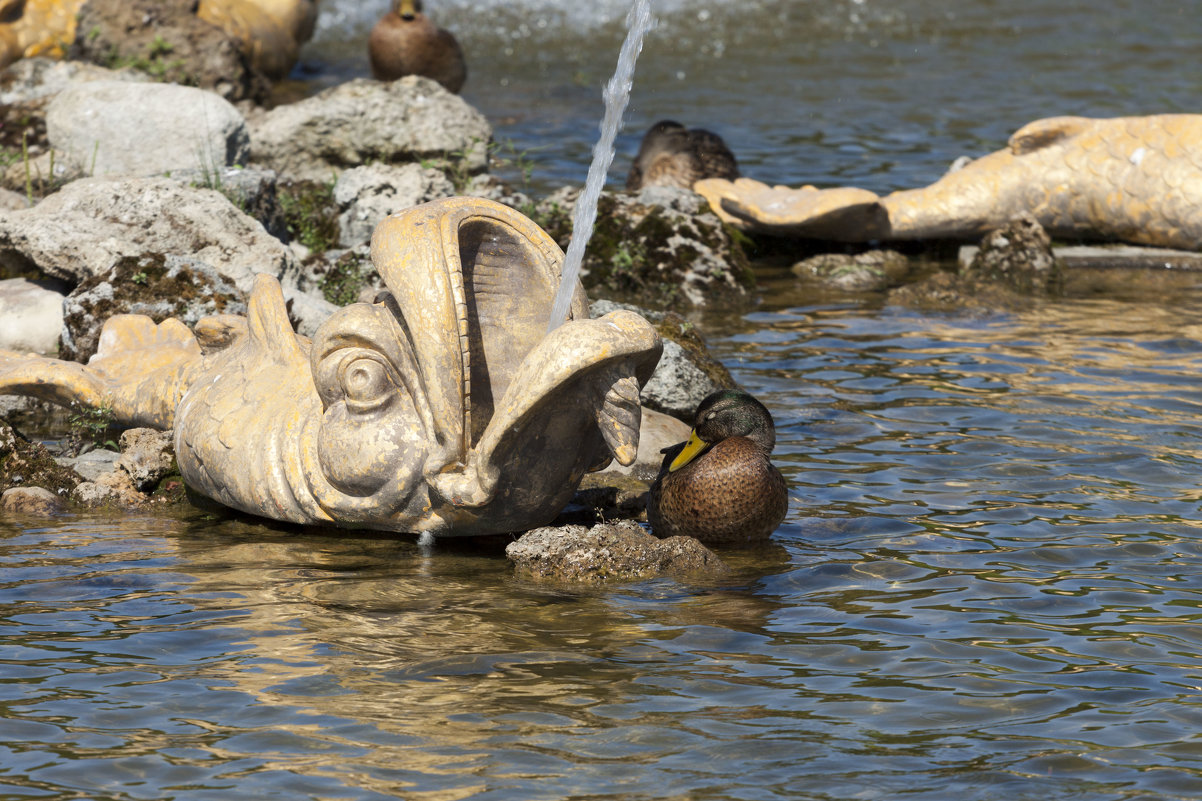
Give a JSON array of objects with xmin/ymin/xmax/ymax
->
[{"xmin": 505, "ymin": 521, "xmax": 730, "ymax": 583}]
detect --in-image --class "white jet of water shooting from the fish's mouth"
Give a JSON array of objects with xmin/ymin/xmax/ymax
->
[{"xmin": 547, "ymin": 0, "xmax": 651, "ymax": 332}]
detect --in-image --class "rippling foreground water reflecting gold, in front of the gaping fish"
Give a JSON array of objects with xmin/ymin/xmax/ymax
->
[{"xmin": 0, "ymin": 292, "xmax": 1202, "ymax": 800}]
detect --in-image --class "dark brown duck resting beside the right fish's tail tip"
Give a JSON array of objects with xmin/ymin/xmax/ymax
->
[{"xmin": 626, "ymin": 119, "xmax": 739, "ymax": 191}]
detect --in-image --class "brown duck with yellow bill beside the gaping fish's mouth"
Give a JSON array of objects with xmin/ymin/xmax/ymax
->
[{"xmin": 647, "ymin": 390, "xmax": 789, "ymax": 542}]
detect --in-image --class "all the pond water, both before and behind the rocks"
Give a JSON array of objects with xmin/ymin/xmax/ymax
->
[{"xmin": 0, "ymin": 0, "xmax": 1202, "ymax": 801}]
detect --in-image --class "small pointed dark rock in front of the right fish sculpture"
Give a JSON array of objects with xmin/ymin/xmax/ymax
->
[{"xmin": 962, "ymin": 212, "xmax": 1063, "ymax": 295}]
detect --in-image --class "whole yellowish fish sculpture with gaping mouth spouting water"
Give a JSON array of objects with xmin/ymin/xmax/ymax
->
[{"xmin": 0, "ymin": 197, "xmax": 661, "ymax": 535}]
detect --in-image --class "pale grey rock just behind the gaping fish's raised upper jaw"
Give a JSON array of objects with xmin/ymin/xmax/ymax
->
[{"xmin": 334, "ymin": 164, "xmax": 456, "ymax": 248}]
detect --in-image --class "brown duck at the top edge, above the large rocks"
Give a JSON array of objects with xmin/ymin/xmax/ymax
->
[{"xmin": 368, "ymin": 0, "xmax": 468, "ymax": 93}]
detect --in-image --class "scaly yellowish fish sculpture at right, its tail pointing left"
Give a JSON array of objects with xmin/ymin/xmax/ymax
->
[{"xmin": 694, "ymin": 114, "xmax": 1202, "ymax": 250}]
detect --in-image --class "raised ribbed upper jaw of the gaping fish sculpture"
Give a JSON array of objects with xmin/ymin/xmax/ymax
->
[{"xmin": 371, "ymin": 197, "xmax": 588, "ymax": 465}]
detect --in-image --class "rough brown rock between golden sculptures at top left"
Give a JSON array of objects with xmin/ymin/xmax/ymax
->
[{"xmin": 70, "ymin": 0, "xmax": 270, "ymax": 101}]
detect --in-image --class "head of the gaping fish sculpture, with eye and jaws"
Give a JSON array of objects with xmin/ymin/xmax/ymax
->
[{"xmin": 299, "ymin": 197, "xmax": 661, "ymax": 529}]
